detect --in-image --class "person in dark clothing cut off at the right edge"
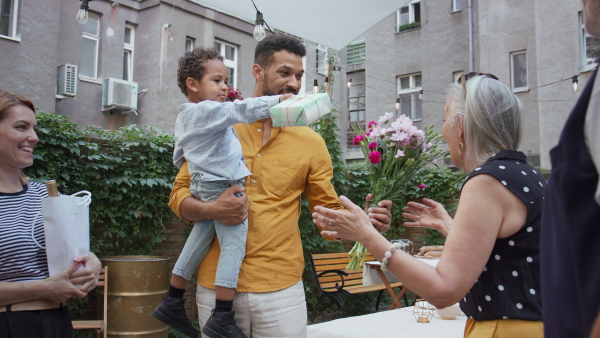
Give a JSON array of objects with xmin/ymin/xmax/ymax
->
[{"xmin": 541, "ymin": 0, "xmax": 600, "ymax": 338}]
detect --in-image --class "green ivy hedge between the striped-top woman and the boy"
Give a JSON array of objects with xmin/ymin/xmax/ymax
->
[{"xmin": 24, "ymin": 113, "xmax": 177, "ymax": 256}]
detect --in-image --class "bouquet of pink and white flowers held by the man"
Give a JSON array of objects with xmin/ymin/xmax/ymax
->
[{"xmin": 346, "ymin": 113, "xmax": 442, "ymax": 270}]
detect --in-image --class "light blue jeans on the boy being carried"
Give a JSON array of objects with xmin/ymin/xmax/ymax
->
[{"xmin": 173, "ymin": 175, "xmax": 248, "ymax": 289}]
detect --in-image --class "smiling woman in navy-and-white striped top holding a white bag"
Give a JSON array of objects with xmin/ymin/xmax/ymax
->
[{"xmin": 0, "ymin": 90, "xmax": 101, "ymax": 338}]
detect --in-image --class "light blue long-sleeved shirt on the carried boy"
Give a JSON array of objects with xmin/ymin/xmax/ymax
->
[{"xmin": 173, "ymin": 95, "xmax": 280, "ymax": 181}]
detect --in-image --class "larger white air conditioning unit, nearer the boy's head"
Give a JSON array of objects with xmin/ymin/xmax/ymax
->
[{"xmin": 102, "ymin": 77, "xmax": 138, "ymax": 113}]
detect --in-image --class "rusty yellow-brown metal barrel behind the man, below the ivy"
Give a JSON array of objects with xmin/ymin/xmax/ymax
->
[{"xmin": 97, "ymin": 256, "xmax": 169, "ymax": 338}]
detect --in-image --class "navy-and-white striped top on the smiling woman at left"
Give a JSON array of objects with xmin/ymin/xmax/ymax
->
[{"xmin": 0, "ymin": 182, "xmax": 49, "ymax": 282}]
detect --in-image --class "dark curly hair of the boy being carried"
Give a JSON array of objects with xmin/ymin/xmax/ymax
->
[{"xmin": 177, "ymin": 47, "xmax": 223, "ymax": 97}]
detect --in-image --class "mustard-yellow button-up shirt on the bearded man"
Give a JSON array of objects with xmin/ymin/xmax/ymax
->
[{"xmin": 169, "ymin": 121, "xmax": 343, "ymax": 292}]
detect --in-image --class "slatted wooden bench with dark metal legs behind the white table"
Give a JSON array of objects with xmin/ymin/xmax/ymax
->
[{"xmin": 310, "ymin": 252, "xmax": 406, "ymax": 323}]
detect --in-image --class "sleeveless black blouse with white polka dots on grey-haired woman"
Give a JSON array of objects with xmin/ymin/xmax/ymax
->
[{"xmin": 460, "ymin": 150, "xmax": 546, "ymax": 321}]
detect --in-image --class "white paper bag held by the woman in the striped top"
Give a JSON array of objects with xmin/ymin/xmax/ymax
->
[{"xmin": 31, "ymin": 190, "xmax": 92, "ymax": 276}]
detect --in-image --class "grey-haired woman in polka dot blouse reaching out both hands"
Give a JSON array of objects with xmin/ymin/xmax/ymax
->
[{"xmin": 313, "ymin": 73, "xmax": 545, "ymax": 337}]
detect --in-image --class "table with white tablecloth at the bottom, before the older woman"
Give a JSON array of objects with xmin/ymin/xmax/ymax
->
[{"xmin": 307, "ymin": 306, "xmax": 467, "ymax": 338}]
